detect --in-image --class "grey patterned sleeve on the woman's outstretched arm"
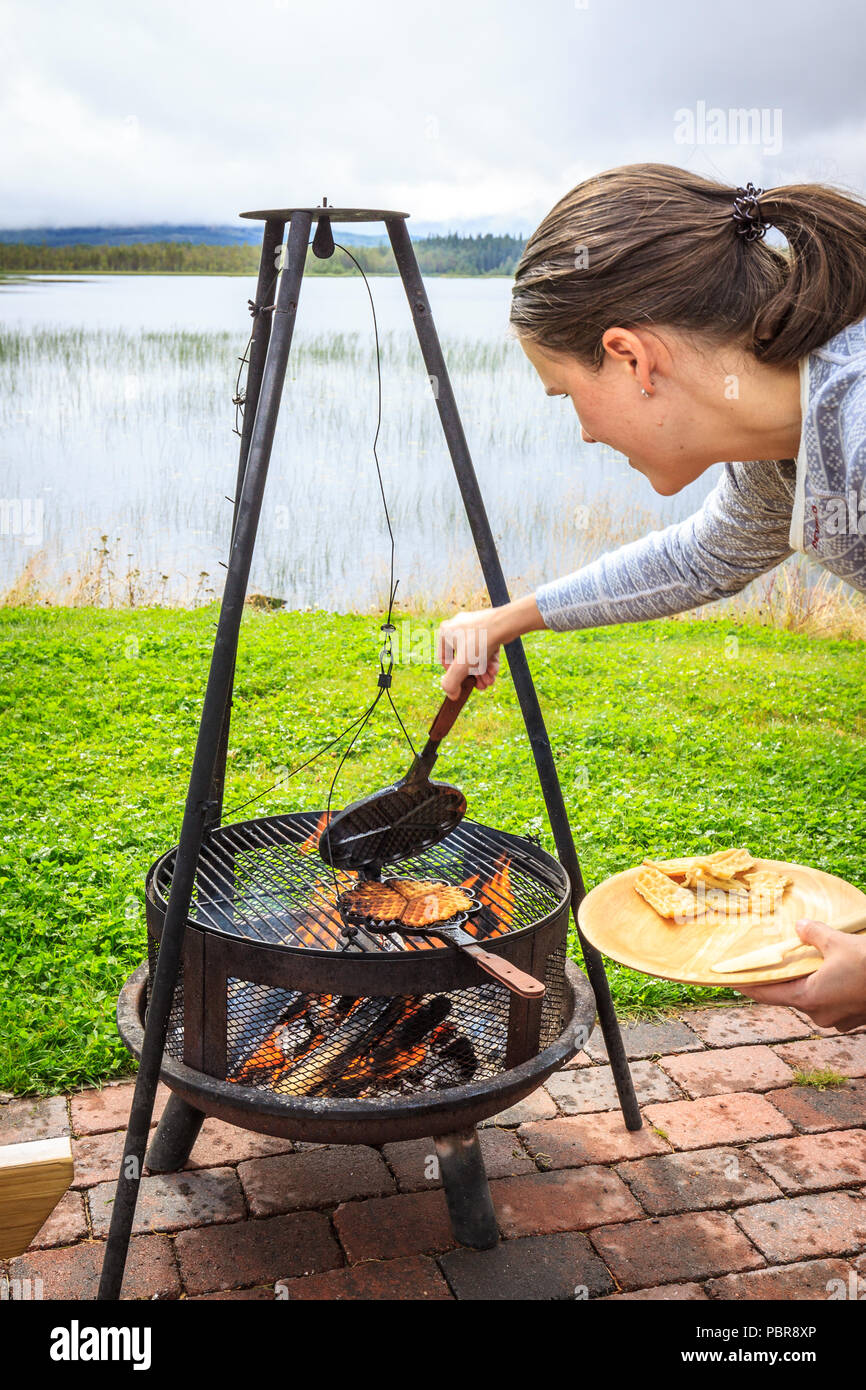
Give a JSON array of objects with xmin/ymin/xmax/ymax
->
[{"xmin": 535, "ymin": 459, "xmax": 796, "ymax": 632}]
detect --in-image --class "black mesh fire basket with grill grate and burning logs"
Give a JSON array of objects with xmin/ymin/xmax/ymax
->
[{"xmin": 147, "ymin": 810, "xmax": 569, "ymax": 1104}]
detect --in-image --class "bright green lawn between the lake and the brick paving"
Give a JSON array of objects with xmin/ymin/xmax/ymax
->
[{"xmin": 0, "ymin": 607, "xmax": 866, "ymax": 1094}]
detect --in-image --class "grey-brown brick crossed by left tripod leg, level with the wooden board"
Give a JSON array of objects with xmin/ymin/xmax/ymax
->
[{"xmin": 88, "ymin": 1168, "xmax": 246, "ymax": 1236}]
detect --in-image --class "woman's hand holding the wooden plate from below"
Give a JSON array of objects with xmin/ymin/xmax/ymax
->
[{"xmin": 737, "ymin": 922, "xmax": 866, "ymax": 1033}]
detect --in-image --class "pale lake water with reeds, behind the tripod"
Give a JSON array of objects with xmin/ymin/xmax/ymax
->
[{"xmin": 0, "ymin": 275, "xmax": 717, "ymax": 610}]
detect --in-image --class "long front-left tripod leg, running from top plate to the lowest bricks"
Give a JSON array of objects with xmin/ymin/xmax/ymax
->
[{"xmin": 99, "ymin": 213, "xmax": 311, "ymax": 1300}]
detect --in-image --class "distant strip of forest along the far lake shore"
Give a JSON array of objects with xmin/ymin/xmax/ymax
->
[{"xmin": 0, "ymin": 232, "xmax": 524, "ymax": 275}]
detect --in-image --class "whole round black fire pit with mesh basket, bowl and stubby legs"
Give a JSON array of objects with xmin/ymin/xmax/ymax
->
[{"xmin": 117, "ymin": 812, "xmax": 595, "ymax": 1250}]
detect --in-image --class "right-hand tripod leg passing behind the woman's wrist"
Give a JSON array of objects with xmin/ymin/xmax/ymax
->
[{"xmin": 385, "ymin": 218, "xmax": 642, "ymax": 1130}]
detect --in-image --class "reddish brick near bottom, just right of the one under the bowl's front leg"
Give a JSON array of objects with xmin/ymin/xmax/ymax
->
[{"xmin": 589, "ymin": 1208, "xmax": 763, "ymax": 1290}]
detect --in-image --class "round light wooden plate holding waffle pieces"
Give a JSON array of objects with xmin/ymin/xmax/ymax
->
[{"xmin": 577, "ymin": 859, "xmax": 866, "ymax": 987}]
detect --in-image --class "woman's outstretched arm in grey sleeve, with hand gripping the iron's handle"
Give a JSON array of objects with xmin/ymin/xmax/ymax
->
[{"xmin": 436, "ymin": 460, "xmax": 795, "ymax": 696}]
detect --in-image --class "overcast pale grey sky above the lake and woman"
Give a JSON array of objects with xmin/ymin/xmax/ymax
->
[{"xmin": 0, "ymin": 0, "xmax": 866, "ymax": 231}]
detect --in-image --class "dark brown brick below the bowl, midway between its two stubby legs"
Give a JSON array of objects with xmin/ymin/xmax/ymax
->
[{"xmin": 238, "ymin": 1144, "xmax": 395, "ymax": 1216}]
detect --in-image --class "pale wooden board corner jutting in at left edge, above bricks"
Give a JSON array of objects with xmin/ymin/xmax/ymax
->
[{"xmin": 0, "ymin": 1138, "xmax": 74, "ymax": 1259}]
